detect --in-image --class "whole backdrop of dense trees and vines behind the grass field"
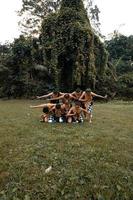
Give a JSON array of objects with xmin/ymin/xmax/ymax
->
[{"xmin": 0, "ymin": 0, "xmax": 133, "ymax": 99}]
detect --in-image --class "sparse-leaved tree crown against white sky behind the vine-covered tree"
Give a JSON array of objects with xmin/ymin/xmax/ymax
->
[{"xmin": 18, "ymin": 0, "xmax": 100, "ymax": 36}]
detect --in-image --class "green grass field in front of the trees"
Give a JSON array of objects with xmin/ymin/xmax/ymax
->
[{"xmin": 0, "ymin": 100, "xmax": 133, "ymax": 200}]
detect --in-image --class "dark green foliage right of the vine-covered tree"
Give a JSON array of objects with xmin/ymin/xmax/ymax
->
[{"xmin": 106, "ymin": 35, "xmax": 133, "ymax": 99}]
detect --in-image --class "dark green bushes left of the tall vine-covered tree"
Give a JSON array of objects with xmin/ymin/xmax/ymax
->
[{"xmin": 0, "ymin": 36, "xmax": 52, "ymax": 98}]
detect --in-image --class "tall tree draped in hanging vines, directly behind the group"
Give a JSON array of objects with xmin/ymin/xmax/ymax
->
[{"xmin": 41, "ymin": 0, "xmax": 115, "ymax": 90}]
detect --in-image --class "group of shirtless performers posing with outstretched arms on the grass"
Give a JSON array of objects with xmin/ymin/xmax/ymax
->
[{"xmin": 30, "ymin": 88, "xmax": 107, "ymax": 123}]
